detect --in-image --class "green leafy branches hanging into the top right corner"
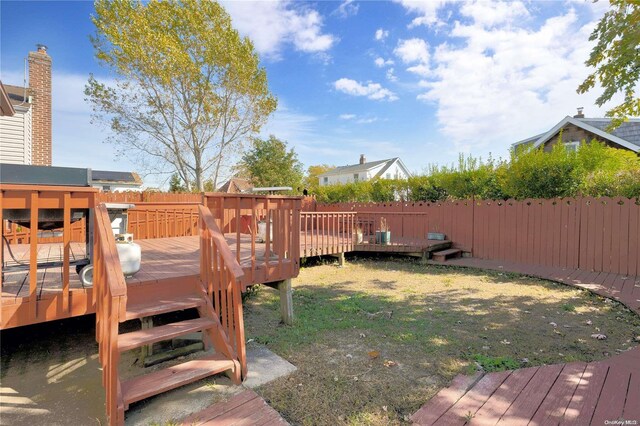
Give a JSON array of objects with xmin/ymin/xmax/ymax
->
[{"xmin": 578, "ymin": 0, "xmax": 640, "ymax": 128}]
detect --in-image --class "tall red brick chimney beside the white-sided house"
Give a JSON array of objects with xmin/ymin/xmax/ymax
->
[{"xmin": 29, "ymin": 44, "xmax": 52, "ymax": 166}]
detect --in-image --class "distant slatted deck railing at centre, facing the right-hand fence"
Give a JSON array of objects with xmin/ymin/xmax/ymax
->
[{"xmin": 300, "ymin": 212, "xmax": 356, "ymax": 257}]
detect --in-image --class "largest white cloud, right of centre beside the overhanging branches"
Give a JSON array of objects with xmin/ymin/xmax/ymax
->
[{"xmin": 417, "ymin": 4, "xmax": 615, "ymax": 152}]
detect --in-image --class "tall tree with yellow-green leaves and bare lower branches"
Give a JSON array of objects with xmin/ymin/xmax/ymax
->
[{"xmin": 85, "ymin": 0, "xmax": 277, "ymax": 190}]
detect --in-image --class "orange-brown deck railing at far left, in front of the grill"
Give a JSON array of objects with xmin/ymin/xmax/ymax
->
[{"xmin": 0, "ymin": 184, "xmax": 97, "ymax": 328}]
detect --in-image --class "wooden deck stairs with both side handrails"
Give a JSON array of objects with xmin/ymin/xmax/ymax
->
[{"xmin": 93, "ymin": 204, "xmax": 247, "ymax": 426}]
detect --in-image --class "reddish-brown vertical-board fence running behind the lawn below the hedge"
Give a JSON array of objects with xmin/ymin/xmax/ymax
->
[{"xmin": 317, "ymin": 197, "xmax": 640, "ymax": 275}]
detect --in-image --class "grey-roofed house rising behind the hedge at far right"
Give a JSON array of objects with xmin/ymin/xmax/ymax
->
[{"xmin": 512, "ymin": 108, "xmax": 640, "ymax": 153}]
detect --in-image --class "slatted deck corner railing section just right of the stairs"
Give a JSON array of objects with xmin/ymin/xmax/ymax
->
[{"xmin": 205, "ymin": 193, "xmax": 301, "ymax": 287}]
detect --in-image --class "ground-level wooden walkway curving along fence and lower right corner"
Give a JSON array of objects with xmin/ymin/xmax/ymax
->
[{"xmin": 411, "ymin": 258, "xmax": 640, "ymax": 425}]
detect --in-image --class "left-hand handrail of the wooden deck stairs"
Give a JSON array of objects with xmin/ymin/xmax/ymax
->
[{"xmin": 93, "ymin": 204, "xmax": 127, "ymax": 425}]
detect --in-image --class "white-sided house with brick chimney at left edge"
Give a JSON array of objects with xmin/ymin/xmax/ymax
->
[{"xmin": 0, "ymin": 45, "xmax": 52, "ymax": 166}]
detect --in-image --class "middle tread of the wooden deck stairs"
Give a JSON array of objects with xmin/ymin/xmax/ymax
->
[{"xmin": 118, "ymin": 318, "xmax": 216, "ymax": 352}]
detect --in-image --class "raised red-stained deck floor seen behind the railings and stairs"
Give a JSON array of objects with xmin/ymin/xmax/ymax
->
[{"xmin": 2, "ymin": 234, "xmax": 297, "ymax": 328}]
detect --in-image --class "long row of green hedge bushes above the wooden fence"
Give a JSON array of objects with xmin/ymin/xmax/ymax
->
[{"xmin": 312, "ymin": 141, "xmax": 640, "ymax": 203}]
